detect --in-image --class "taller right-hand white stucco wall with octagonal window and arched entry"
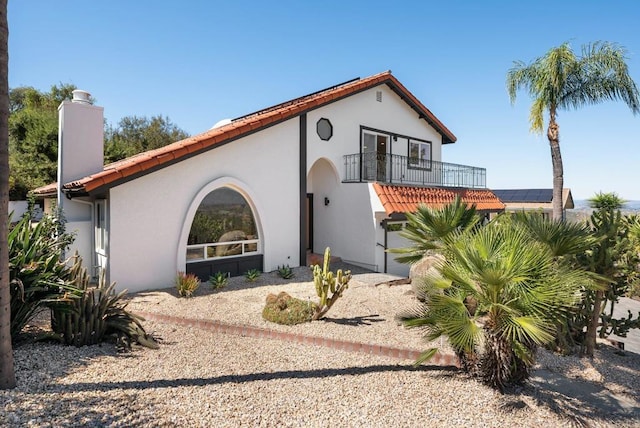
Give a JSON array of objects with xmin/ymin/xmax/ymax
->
[{"xmin": 307, "ymin": 85, "xmax": 442, "ymax": 271}]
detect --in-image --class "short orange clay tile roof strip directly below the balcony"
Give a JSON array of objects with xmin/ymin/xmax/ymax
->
[{"xmin": 373, "ymin": 183, "xmax": 505, "ymax": 215}]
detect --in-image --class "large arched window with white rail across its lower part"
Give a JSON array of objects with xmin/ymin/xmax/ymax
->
[{"xmin": 187, "ymin": 187, "xmax": 260, "ymax": 263}]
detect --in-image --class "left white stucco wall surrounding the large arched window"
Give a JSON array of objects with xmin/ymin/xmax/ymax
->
[{"xmin": 109, "ymin": 118, "xmax": 300, "ymax": 291}]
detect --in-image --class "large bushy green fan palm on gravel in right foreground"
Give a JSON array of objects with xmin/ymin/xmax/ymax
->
[{"xmin": 400, "ymin": 217, "xmax": 584, "ymax": 390}]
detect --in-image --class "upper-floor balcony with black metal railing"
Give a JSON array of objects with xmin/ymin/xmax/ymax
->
[{"xmin": 344, "ymin": 153, "xmax": 487, "ymax": 189}]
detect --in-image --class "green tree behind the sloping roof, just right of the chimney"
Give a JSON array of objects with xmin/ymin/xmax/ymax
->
[{"xmin": 105, "ymin": 116, "xmax": 189, "ymax": 163}]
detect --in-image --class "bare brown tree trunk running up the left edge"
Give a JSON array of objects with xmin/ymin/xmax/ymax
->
[{"xmin": 0, "ymin": 0, "xmax": 16, "ymax": 389}]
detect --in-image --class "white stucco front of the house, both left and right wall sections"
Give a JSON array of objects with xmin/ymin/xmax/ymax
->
[{"xmin": 109, "ymin": 81, "xmax": 452, "ymax": 291}]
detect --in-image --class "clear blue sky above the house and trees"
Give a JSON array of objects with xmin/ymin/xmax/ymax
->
[{"xmin": 9, "ymin": 0, "xmax": 640, "ymax": 200}]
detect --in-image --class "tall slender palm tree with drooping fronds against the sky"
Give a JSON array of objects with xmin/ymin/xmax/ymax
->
[{"xmin": 507, "ymin": 42, "xmax": 640, "ymax": 220}]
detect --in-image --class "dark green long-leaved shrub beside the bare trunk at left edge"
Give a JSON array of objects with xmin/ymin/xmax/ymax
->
[{"xmin": 7, "ymin": 212, "xmax": 77, "ymax": 340}]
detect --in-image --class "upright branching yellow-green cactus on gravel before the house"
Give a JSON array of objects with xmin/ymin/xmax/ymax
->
[{"xmin": 312, "ymin": 247, "xmax": 351, "ymax": 320}]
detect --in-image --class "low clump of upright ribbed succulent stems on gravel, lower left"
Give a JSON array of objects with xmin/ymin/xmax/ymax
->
[{"xmin": 51, "ymin": 256, "xmax": 158, "ymax": 349}]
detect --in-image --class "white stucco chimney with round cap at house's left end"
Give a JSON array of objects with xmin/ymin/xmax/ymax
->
[{"xmin": 58, "ymin": 89, "xmax": 104, "ymax": 200}]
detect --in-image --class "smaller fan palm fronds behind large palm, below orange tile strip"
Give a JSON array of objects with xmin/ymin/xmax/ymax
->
[{"xmin": 389, "ymin": 196, "xmax": 480, "ymax": 264}]
